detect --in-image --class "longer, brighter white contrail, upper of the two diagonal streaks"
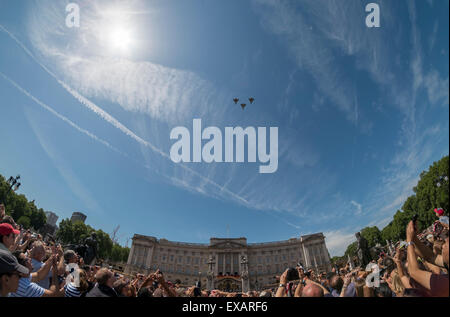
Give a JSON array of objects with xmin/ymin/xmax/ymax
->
[{"xmin": 0, "ymin": 24, "xmax": 251, "ymax": 207}]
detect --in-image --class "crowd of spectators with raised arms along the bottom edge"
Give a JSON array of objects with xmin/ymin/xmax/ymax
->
[{"xmin": 0, "ymin": 205, "xmax": 449, "ymax": 297}]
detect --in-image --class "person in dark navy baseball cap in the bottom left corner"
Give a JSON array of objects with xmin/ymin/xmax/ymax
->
[{"xmin": 0, "ymin": 250, "xmax": 29, "ymax": 297}]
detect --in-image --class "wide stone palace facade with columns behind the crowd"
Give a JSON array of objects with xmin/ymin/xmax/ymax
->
[{"xmin": 125, "ymin": 233, "xmax": 331, "ymax": 291}]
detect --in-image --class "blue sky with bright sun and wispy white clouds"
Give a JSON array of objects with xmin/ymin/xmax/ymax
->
[{"xmin": 0, "ymin": 0, "xmax": 449, "ymax": 255}]
